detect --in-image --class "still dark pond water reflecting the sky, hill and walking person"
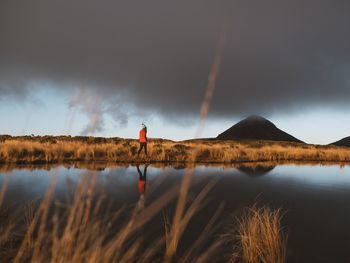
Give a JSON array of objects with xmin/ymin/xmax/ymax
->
[{"xmin": 0, "ymin": 164, "xmax": 350, "ymax": 262}]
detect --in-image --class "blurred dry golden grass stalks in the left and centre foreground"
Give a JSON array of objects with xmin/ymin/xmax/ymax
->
[{"xmin": 0, "ymin": 170, "xmax": 224, "ymax": 263}]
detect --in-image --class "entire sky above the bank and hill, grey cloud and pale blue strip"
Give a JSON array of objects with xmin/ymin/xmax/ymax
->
[{"xmin": 0, "ymin": 0, "xmax": 350, "ymax": 143}]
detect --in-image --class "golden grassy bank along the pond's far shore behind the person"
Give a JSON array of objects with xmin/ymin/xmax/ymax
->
[{"xmin": 0, "ymin": 136, "xmax": 350, "ymax": 163}]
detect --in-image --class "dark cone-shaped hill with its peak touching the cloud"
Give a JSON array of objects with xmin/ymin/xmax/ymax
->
[{"xmin": 217, "ymin": 115, "xmax": 302, "ymax": 142}]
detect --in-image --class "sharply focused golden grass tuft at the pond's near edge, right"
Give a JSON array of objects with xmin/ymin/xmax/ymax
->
[{"xmin": 232, "ymin": 205, "xmax": 287, "ymax": 263}]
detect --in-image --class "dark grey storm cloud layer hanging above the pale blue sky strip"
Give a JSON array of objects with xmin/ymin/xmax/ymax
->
[{"xmin": 0, "ymin": 0, "xmax": 350, "ymax": 118}]
